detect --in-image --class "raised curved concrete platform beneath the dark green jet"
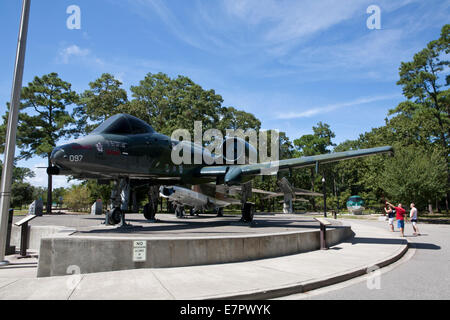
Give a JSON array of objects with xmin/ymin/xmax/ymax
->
[{"xmin": 33, "ymin": 215, "xmax": 353, "ymax": 277}]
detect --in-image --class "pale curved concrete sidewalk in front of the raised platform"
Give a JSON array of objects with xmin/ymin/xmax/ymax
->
[{"xmin": 0, "ymin": 221, "xmax": 407, "ymax": 300}]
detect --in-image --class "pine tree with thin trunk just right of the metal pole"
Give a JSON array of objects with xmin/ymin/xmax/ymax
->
[{"xmin": 9, "ymin": 73, "xmax": 78, "ymax": 214}]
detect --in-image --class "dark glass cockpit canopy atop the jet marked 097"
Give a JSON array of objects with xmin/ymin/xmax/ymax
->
[{"xmin": 91, "ymin": 113, "xmax": 155, "ymax": 135}]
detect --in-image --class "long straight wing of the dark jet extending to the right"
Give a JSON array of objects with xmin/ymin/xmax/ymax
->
[{"xmin": 198, "ymin": 146, "xmax": 394, "ymax": 185}]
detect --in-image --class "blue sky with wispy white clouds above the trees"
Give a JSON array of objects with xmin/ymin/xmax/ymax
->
[{"xmin": 0, "ymin": 0, "xmax": 450, "ymax": 186}]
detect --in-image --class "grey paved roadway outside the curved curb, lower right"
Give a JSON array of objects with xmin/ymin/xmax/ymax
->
[{"xmin": 283, "ymin": 221, "xmax": 450, "ymax": 300}]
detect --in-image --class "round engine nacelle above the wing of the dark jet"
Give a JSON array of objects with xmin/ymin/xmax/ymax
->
[{"xmin": 220, "ymin": 137, "xmax": 258, "ymax": 164}]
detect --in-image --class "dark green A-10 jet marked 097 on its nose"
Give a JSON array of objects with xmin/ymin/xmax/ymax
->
[{"xmin": 47, "ymin": 114, "xmax": 393, "ymax": 224}]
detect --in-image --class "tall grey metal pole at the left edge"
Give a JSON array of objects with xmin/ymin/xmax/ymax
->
[{"xmin": 0, "ymin": 0, "xmax": 31, "ymax": 265}]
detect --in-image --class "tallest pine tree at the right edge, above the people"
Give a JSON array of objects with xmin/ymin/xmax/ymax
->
[{"xmin": 390, "ymin": 24, "xmax": 450, "ymax": 211}]
